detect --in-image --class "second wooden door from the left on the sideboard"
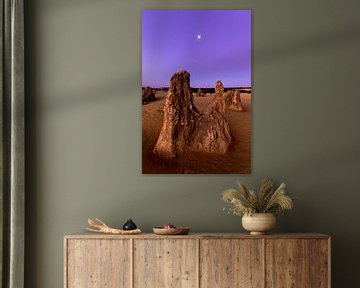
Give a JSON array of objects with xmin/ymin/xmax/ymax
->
[{"xmin": 134, "ymin": 239, "xmax": 198, "ymax": 288}]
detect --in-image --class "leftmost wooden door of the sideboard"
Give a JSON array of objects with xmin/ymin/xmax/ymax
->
[{"xmin": 65, "ymin": 239, "xmax": 132, "ymax": 288}]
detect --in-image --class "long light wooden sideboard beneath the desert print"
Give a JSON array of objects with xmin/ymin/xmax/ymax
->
[{"xmin": 64, "ymin": 233, "xmax": 331, "ymax": 288}]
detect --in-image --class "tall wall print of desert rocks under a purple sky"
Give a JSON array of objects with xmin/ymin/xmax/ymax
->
[{"xmin": 142, "ymin": 10, "xmax": 252, "ymax": 174}]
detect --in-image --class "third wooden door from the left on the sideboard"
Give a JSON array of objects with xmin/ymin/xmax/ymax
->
[{"xmin": 200, "ymin": 239, "xmax": 264, "ymax": 288}]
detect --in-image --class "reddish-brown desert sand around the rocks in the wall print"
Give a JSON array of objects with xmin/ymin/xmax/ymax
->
[{"xmin": 142, "ymin": 91, "xmax": 251, "ymax": 174}]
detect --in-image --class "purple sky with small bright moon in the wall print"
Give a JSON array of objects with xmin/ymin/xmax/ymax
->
[{"xmin": 142, "ymin": 10, "xmax": 251, "ymax": 87}]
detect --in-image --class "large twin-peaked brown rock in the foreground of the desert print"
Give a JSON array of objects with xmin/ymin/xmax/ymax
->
[{"xmin": 154, "ymin": 71, "xmax": 231, "ymax": 160}]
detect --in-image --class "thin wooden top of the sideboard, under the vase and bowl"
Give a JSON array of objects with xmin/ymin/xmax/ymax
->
[{"xmin": 64, "ymin": 232, "xmax": 330, "ymax": 239}]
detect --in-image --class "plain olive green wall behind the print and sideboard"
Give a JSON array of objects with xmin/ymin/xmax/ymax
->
[{"xmin": 25, "ymin": 0, "xmax": 360, "ymax": 288}]
